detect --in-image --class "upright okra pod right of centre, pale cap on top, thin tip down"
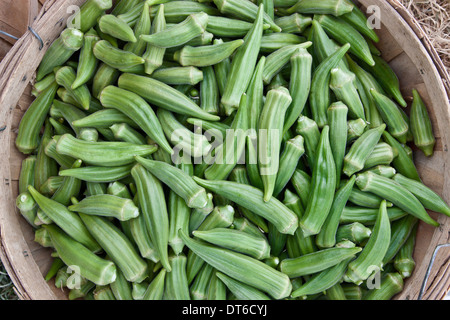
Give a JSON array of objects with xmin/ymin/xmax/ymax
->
[{"xmin": 327, "ymin": 101, "xmax": 348, "ymax": 187}]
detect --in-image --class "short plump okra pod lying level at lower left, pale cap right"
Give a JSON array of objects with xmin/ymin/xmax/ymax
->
[{"xmin": 68, "ymin": 194, "xmax": 139, "ymax": 221}]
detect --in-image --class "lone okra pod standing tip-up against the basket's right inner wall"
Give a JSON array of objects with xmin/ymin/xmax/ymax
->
[{"xmin": 410, "ymin": 89, "xmax": 436, "ymax": 157}]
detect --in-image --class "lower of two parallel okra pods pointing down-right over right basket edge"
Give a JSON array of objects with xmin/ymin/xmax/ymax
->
[{"xmin": 356, "ymin": 171, "xmax": 439, "ymax": 227}]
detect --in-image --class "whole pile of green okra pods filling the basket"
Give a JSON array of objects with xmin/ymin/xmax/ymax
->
[{"xmin": 16, "ymin": 0, "xmax": 450, "ymax": 300}]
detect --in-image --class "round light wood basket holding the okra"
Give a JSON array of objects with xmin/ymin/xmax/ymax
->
[{"xmin": 0, "ymin": 0, "xmax": 450, "ymax": 300}]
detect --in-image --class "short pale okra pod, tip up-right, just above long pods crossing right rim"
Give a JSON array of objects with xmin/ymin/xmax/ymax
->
[{"xmin": 343, "ymin": 124, "xmax": 386, "ymax": 177}]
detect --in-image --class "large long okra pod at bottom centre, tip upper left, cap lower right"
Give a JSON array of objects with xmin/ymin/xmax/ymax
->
[{"xmin": 180, "ymin": 232, "xmax": 292, "ymax": 299}]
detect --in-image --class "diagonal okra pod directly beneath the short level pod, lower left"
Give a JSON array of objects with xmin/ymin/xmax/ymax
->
[{"xmin": 80, "ymin": 213, "xmax": 147, "ymax": 282}]
